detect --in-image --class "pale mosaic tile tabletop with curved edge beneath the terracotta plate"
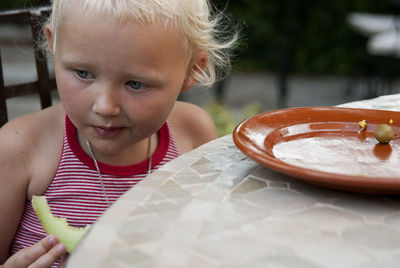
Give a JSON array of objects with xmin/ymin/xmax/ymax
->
[{"xmin": 67, "ymin": 95, "xmax": 400, "ymax": 268}]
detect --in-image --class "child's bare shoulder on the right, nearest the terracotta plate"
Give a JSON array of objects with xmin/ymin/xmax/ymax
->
[{"xmin": 168, "ymin": 101, "xmax": 218, "ymax": 153}]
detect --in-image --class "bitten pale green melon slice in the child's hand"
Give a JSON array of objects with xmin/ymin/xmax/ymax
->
[{"xmin": 32, "ymin": 196, "xmax": 90, "ymax": 253}]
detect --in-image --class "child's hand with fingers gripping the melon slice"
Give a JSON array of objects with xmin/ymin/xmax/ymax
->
[{"xmin": 1, "ymin": 235, "xmax": 67, "ymax": 268}]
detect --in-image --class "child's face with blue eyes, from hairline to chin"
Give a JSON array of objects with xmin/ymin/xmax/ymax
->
[{"xmin": 47, "ymin": 9, "xmax": 193, "ymax": 161}]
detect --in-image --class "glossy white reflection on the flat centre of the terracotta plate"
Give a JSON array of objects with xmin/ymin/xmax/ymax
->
[{"xmin": 272, "ymin": 136, "xmax": 400, "ymax": 179}]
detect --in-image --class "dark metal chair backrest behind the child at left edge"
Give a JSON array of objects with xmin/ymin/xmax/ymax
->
[{"xmin": 0, "ymin": 7, "xmax": 56, "ymax": 127}]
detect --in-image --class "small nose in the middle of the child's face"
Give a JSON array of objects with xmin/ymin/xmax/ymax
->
[{"xmin": 93, "ymin": 89, "xmax": 121, "ymax": 117}]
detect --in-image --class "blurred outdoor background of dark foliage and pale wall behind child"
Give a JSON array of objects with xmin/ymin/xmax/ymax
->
[{"xmin": 0, "ymin": 0, "xmax": 400, "ymax": 135}]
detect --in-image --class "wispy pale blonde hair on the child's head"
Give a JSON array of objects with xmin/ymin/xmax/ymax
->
[{"xmin": 48, "ymin": 0, "xmax": 238, "ymax": 86}]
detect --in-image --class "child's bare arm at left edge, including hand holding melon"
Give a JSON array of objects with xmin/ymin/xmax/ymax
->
[{"xmin": 0, "ymin": 111, "xmax": 66, "ymax": 268}]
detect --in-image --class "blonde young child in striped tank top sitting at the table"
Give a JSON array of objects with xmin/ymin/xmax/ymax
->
[{"xmin": 0, "ymin": 0, "xmax": 235, "ymax": 267}]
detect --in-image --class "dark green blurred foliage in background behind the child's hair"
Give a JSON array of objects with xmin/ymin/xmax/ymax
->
[{"xmin": 220, "ymin": 0, "xmax": 399, "ymax": 75}]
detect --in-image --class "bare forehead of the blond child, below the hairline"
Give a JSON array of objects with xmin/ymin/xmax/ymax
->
[{"xmin": 55, "ymin": 12, "xmax": 189, "ymax": 73}]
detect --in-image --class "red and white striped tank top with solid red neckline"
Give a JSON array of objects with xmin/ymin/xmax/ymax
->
[{"xmin": 10, "ymin": 117, "xmax": 179, "ymax": 262}]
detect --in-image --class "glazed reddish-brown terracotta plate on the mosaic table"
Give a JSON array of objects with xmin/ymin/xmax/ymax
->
[{"xmin": 233, "ymin": 107, "xmax": 400, "ymax": 194}]
